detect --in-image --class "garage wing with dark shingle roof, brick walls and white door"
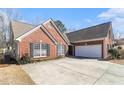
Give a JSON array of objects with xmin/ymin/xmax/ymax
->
[{"xmin": 66, "ymin": 22, "xmax": 114, "ymax": 59}]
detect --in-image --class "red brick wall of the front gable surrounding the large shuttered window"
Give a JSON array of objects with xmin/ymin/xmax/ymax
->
[{"xmin": 19, "ymin": 28, "xmax": 56, "ymax": 58}]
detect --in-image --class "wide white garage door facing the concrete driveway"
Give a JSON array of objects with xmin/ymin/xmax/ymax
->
[{"xmin": 75, "ymin": 44, "xmax": 102, "ymax": 58}]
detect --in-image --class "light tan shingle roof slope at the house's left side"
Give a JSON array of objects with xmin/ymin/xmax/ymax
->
[{"xmin": 11, "ymin": 20, "xmax": 35, "ymax": 39}]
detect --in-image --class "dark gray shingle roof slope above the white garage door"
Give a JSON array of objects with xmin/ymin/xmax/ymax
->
[{"xmin": 66, "ymin": 22, "xmax": 111, "ymax": 42}]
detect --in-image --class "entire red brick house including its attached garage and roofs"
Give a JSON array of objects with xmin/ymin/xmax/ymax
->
[{"xmin": 10, "ymin": 19, "xmax": 114, "ymax": 59}]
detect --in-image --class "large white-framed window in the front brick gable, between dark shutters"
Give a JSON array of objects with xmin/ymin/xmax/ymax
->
[{"xmin": 32, "ymin": 43, "xmax": 49, "ymax": 57}]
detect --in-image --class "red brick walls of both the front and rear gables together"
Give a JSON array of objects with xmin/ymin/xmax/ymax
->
[{"xmin": 19, "ymin": 22, "xmax": 68, "ymax": 58}]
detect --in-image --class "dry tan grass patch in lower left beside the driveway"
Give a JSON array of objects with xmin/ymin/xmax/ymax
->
[{"xmin": 0, "ymin": 65, "xmax": 35, "ymax": 85}]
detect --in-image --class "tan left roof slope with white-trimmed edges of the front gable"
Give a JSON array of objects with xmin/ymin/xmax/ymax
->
[{"xmin": 11, "ymin": 21, "xmax": 57, "ymax": 44}]
